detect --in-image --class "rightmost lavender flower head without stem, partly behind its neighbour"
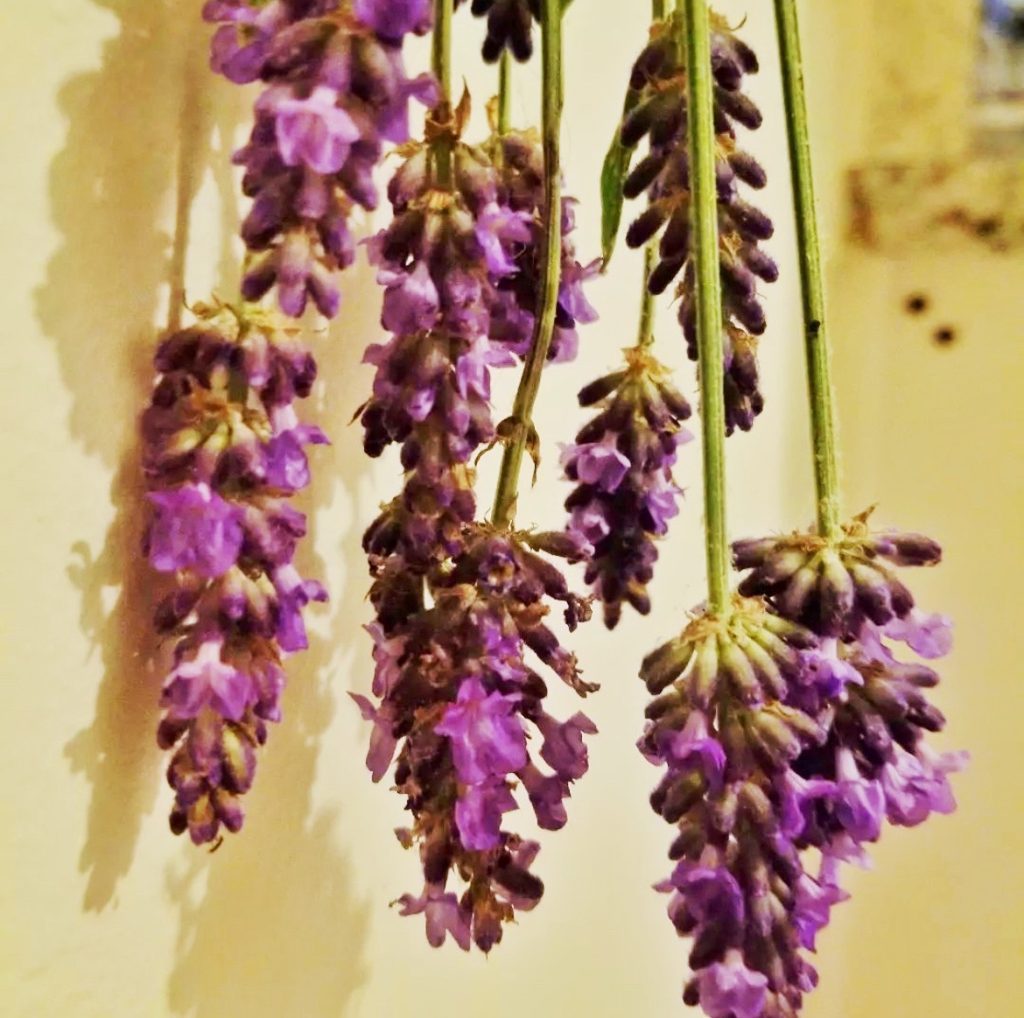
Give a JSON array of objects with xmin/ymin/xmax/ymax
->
[{"xmin": 733, "ymin": 512, "xmax": 967, "ymax": 857}]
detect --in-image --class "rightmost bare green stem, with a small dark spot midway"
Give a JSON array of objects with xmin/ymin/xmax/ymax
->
[{"xmin": 775, "ymin": 0, "xmax": 840, "ymax": 538}]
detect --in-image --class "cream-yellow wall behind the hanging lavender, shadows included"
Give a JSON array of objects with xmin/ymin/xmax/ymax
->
[{"xmin": 0, "ymin": 0, "xmax": 1024, "ymax": 1018}]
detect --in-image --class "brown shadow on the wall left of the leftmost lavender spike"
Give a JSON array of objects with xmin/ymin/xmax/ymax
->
[{"xmin": 35, "ymin": 0, "xmax": 228, "ymax": 910}]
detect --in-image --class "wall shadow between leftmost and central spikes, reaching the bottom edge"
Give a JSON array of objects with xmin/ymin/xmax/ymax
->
[{"xmin": 167, "ymin": 247, "xmax": 386, "ymax": 1018}]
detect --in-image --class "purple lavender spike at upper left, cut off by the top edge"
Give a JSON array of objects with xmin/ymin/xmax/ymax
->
[{"xmin": 203, "ymin": 0, "xmax": 436, "ymax": 317}]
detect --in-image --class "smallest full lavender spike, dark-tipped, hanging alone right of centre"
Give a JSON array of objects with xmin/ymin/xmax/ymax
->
[{"xmin": 562, "ymin": 347, "xmax": 691, "ymax": 629}]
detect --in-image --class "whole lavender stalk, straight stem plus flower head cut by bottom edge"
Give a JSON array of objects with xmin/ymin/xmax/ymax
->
[{"xmin": 640, "ymin": 0, "xmax": 831, "ymax": 1018}]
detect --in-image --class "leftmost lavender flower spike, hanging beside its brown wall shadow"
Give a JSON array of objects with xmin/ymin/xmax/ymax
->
[{"xmin": 142, "ymin": 304, "xmax": 327, "ymax": 844}]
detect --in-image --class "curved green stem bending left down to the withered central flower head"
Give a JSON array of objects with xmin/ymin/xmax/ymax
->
[{"xmin": 493, "ymin": 0, "xmax": 562, "ymax": 526}]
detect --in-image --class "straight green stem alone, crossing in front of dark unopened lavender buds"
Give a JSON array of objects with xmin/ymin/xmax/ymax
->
[{"xmin": 676, "ymin": 0, "xmax": 729, "ymax": 613}]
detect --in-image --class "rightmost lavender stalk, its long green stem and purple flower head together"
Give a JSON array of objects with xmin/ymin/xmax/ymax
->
[{"xmin": 733, "ymin": 0, "xmax": 967, "ymax": 974}]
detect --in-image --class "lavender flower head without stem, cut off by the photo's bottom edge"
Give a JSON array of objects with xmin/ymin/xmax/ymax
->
[{"xmin": 639, "ymin": 597, "xmax": 848, "ymax": 1018}]
